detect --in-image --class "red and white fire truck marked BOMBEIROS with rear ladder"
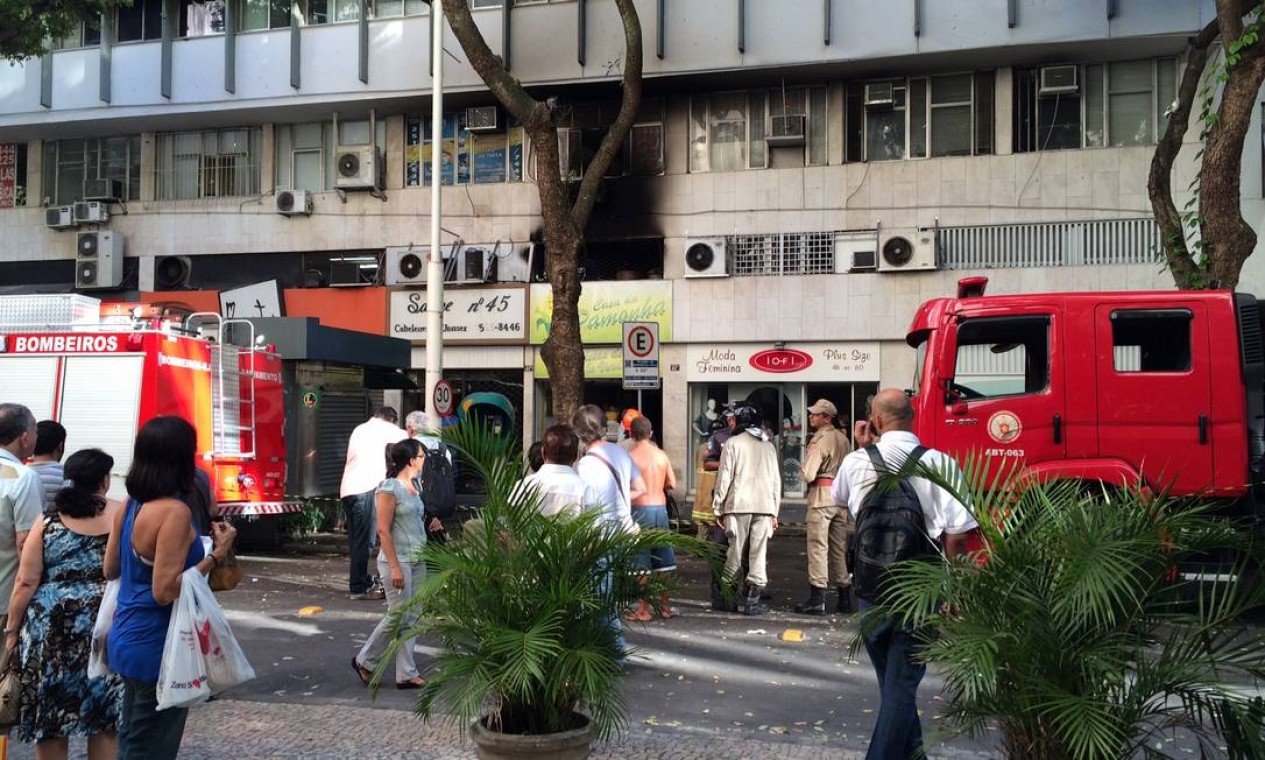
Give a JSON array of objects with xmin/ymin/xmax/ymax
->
[{"xmin": 0, "ymin": 296, "xmax": 301, "ymax": 516}]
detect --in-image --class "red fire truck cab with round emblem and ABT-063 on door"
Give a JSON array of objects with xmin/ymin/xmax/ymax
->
[{"xmin": 907, "ymin": 277, "xmax": 1265, "ymax": 527}]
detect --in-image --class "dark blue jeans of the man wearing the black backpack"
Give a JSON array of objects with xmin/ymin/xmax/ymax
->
[{"xmin": 859, "ymin": 599, "xmax": 927, "ymax": 760}]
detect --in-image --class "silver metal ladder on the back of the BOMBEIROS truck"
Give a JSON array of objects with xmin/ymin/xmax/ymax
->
[{"xmin": 185, "ymin": 311, "xmax": 257, "ymax": 459}]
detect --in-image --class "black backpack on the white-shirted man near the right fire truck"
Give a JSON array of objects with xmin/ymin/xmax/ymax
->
[{"xmin": 850, "ymin": 445, "xmax": 935, "ymax": 602}]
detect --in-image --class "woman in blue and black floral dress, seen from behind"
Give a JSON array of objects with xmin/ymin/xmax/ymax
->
[{"xmin": 5, "ymin": 449, "xmax": 123, "ymax": 760}]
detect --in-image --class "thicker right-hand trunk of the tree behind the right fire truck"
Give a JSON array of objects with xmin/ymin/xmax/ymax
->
[{"xmin": 1199, "ymin": 0, "xmax": 1265, "ymax": 288}]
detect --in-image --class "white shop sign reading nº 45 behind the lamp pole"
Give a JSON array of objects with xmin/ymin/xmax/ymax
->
[{"xmin": 390, "ymin": 287, "xmax": 528, "ymax": 344}]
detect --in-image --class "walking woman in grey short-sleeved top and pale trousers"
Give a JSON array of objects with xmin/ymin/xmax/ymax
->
[{"xmin": 352, "ymin": 438, "xmax": 443, "ymax": 689}]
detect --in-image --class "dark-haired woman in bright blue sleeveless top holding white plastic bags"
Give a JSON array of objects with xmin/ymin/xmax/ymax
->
[{"xmin": 105, "ymin": 417, "xmax": 237, "ymax": 760}]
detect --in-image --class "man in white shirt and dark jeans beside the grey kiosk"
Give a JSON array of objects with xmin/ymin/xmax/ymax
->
[{"xmin": 338, "ymin": 406, "xmax": 409, "ymax": 599}]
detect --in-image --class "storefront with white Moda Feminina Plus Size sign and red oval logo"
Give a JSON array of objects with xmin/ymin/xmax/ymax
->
[{"xmin": 684, "ymin": 341, "xmax": 879, "ymax": 497}]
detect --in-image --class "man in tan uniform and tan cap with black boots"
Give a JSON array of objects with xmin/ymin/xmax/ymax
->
[{"xmin": 794, "ymin": 398, "xmax": 853, "ymax": 615}]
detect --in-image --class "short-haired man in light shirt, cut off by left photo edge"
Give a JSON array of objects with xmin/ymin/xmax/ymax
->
[{"xmin": 0, "ymin": 403, "xmax": 44, "ymax": 637}]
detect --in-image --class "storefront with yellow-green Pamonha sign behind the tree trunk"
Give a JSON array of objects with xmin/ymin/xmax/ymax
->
[{"xmin": 531, "ymin": 279, "xmax": 672, "ymax": 441}]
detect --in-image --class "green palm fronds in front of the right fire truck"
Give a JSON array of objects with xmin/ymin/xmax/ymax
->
[{"xmin": 854, "ymin": 459, "xmax": 1265, "ymax": 760}]
